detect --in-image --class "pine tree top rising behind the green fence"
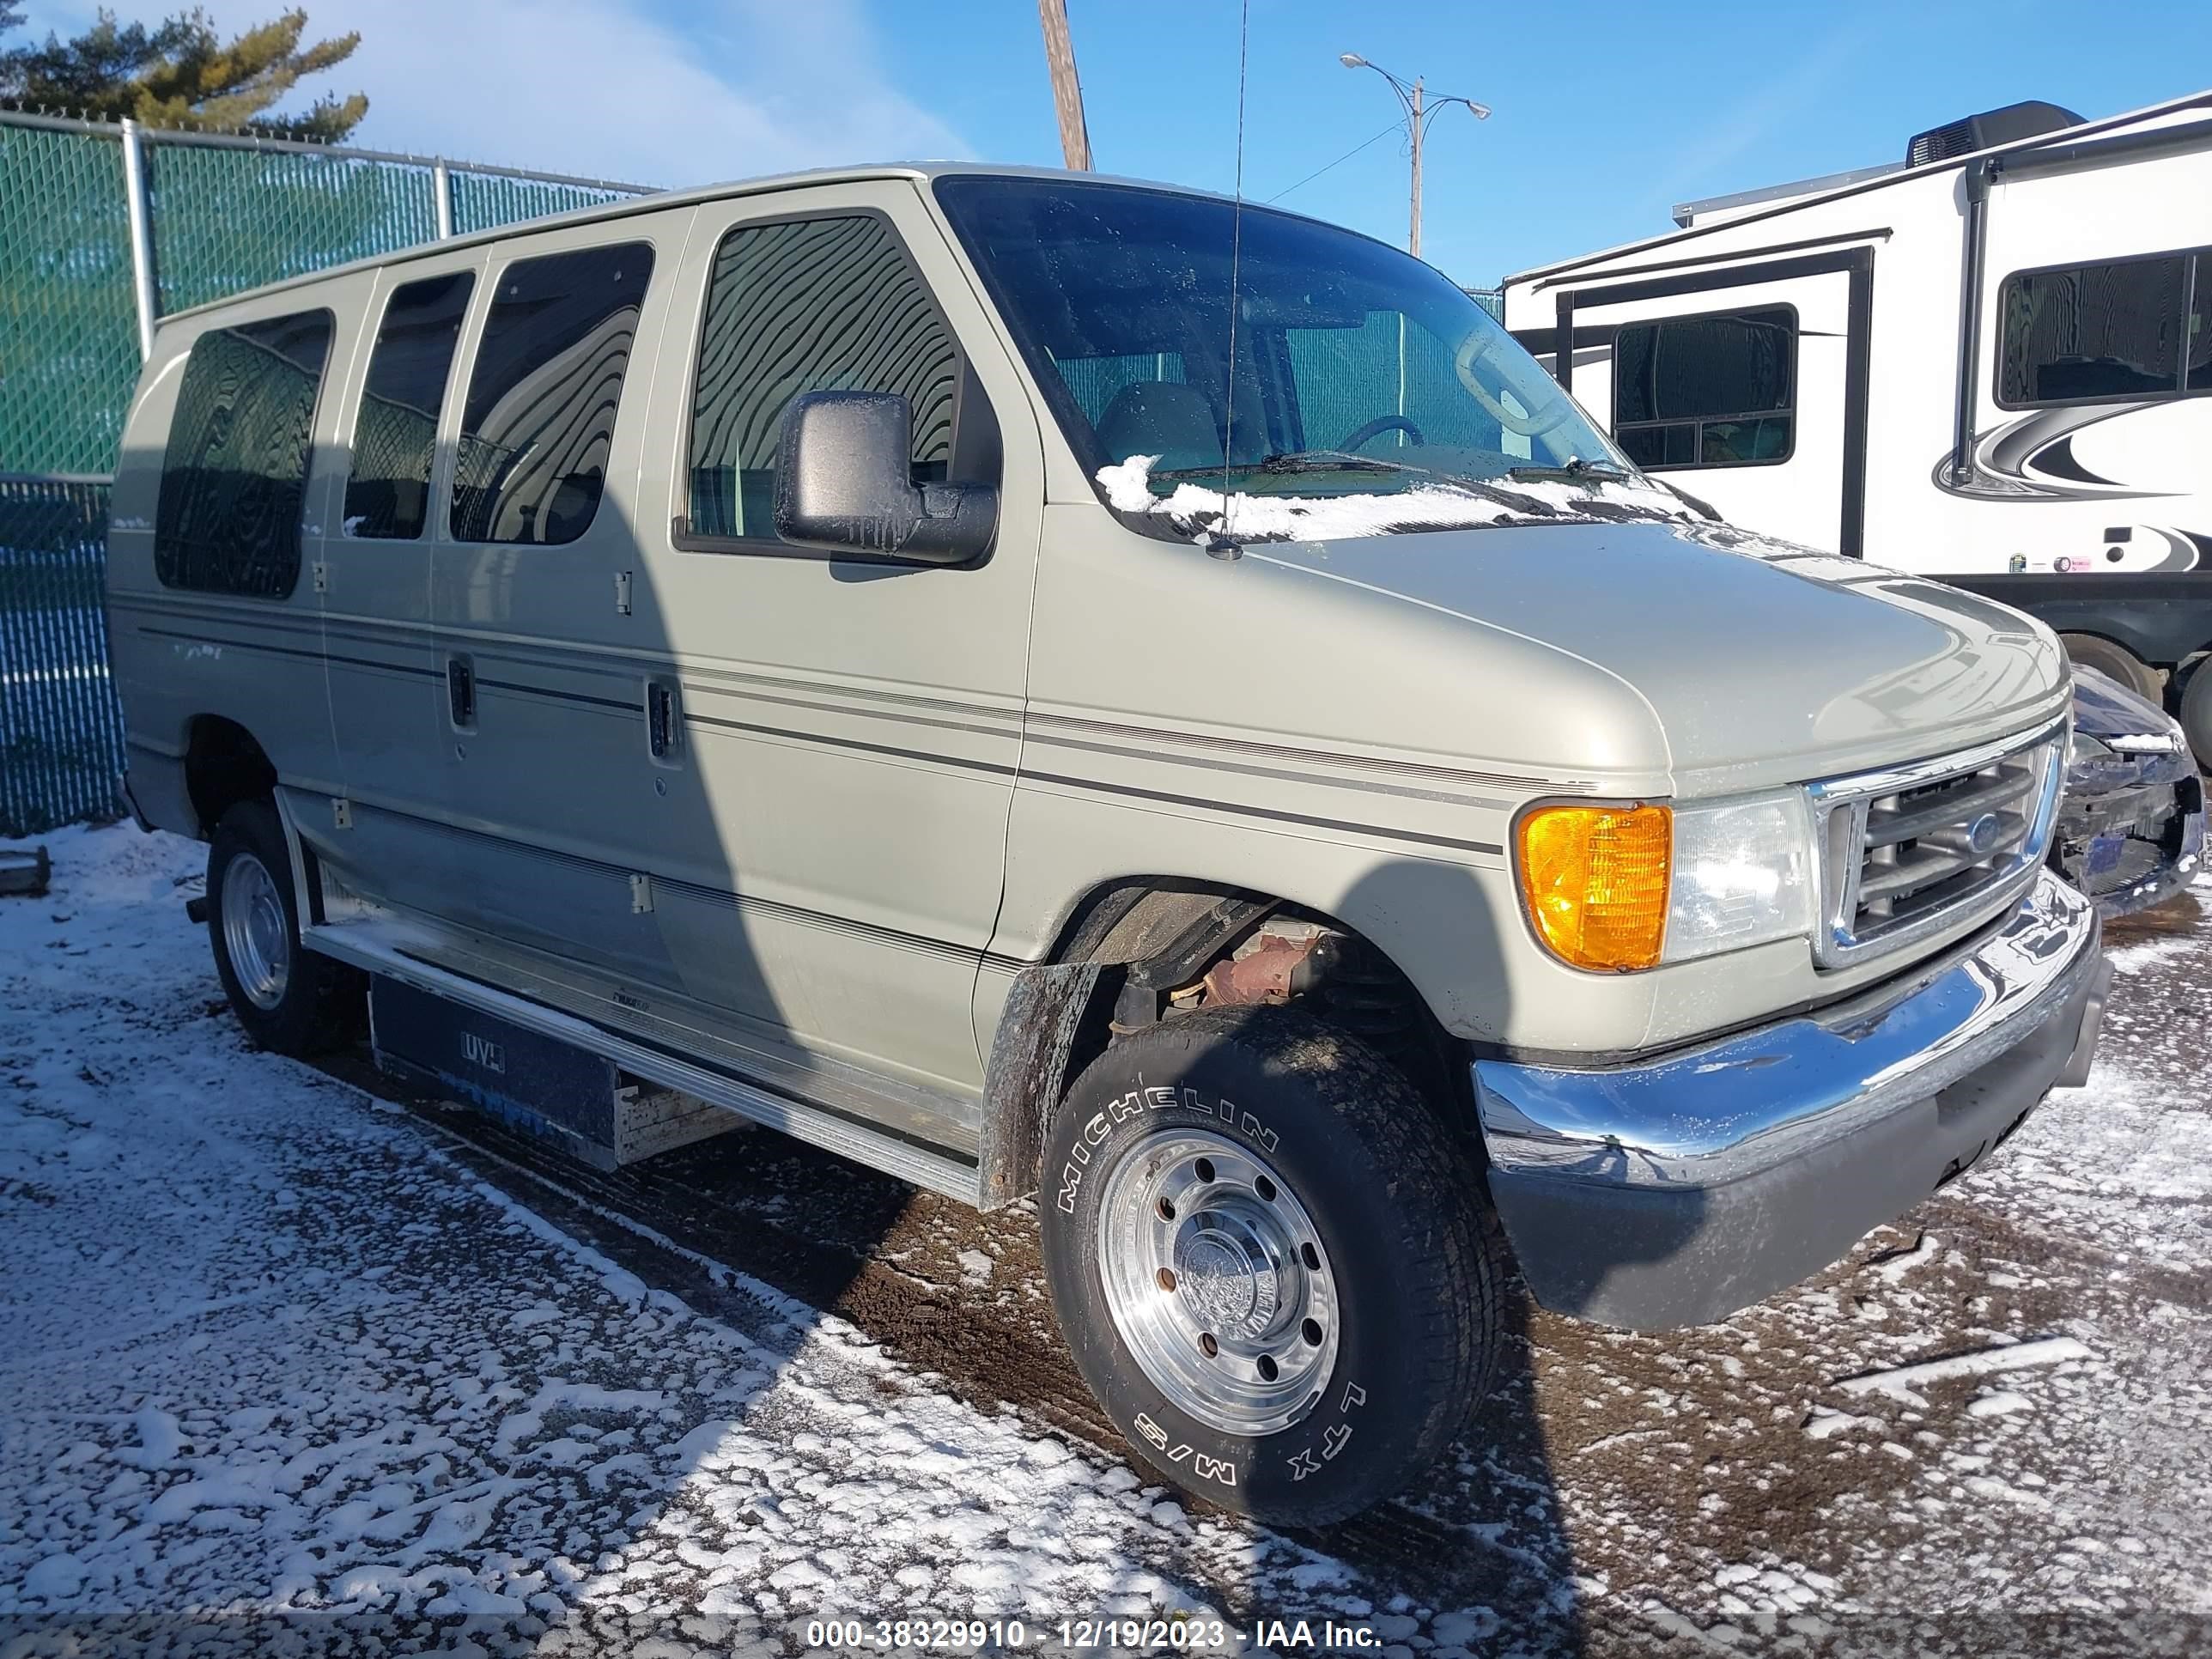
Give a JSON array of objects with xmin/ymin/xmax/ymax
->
[{"xmin": 0, "ymin": 0, "xmax": 369, "ymax": 143}]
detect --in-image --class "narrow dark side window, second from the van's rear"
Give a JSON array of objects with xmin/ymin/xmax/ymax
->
[{"xmin": 345, "ymin": 270, "xmax": 476, "ymax": 542}]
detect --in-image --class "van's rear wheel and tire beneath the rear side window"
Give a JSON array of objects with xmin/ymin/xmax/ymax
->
[{"xmin": 208, "ymin": 801, "xmax": 368, "ymax": 1057}]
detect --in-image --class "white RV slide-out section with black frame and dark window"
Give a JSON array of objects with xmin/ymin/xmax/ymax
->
[{"xmin": 1558, "ymin": 248, "xmax": 1874, "ymax": 557}]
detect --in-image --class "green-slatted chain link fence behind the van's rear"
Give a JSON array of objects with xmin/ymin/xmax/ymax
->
[{"xmin": 0, "ymin": 108, "xmax": 646, "ymax": 836}]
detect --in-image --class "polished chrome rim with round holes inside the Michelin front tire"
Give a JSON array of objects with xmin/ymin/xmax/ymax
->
[{"xmin": 1097, "ymin": 1128, "xmax": 1338, "ymax": 1436}]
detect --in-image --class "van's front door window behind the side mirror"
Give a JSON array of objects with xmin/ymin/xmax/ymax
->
[{"xmin": 688, "ymin": 215, "xmax": 960, "ymax": 540}]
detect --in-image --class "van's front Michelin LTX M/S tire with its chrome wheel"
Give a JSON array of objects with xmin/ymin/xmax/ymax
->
[{"xmin": 1040, "ymin": 1006, "xmax": 1502, "ymax": 1526}]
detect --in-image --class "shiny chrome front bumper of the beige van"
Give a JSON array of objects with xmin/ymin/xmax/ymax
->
[{"xmin": 1475, "ymin": 872, "xmax": 2111, "ymax": 1329}]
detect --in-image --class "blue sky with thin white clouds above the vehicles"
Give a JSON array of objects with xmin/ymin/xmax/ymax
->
[{"xmin": 27, "ymin": 0, "xmax": 2212, "ymax": 283}]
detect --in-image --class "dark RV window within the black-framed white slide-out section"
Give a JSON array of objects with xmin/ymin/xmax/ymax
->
[{"xmin": 1613, "ymin": 305, "xmax": 1798, "ymax": 469}]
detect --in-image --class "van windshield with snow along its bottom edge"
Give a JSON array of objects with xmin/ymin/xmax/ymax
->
[{"xmin": 936, "ymin": 175, "xmax": 1679, "ymax": 548}]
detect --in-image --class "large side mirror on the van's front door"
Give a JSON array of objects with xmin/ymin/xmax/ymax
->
[{"xmin": 776, "ymin": 392, "xmax": 998, "ymax": 564}]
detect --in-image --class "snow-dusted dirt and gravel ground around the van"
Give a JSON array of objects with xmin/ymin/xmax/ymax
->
[{"xmin": 0, "ymin": 827, "xmax": 2212, "ymax": 1659}]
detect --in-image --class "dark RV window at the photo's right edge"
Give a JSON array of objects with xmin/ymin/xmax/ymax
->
[{"xmin": 1997, "ymin": 252, "xmax": 2212, "ymax": 410}]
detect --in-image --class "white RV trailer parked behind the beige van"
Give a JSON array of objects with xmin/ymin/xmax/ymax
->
[{"xmin": 1504, "ymin": 93, "xmax": 2212, "ymax": 763}]
